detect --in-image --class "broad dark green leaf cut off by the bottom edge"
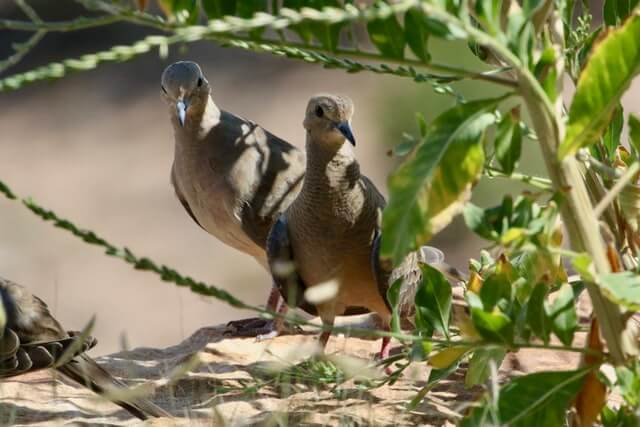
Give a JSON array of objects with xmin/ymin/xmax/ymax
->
[{"xmin": 462, "ymin": 369, "xmax": 590, "ymax": 427}]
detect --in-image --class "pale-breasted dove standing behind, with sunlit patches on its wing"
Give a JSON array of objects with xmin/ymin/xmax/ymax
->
[{"xmin": 162, "ymin": 61, "xmax": 362, "ymax": 336}]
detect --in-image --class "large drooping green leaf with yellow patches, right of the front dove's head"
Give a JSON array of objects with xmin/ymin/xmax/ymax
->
[{"xmin": 381, "ymin": 99, "xmax": 498, "ymax": 264}]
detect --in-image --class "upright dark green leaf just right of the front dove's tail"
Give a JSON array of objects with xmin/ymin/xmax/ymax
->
[{"xmin": 415, "ymin": 265, "xmax": 451, "ymax": 338}]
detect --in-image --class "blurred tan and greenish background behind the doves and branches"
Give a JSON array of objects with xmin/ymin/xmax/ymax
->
[{"xmin": 0, "ymin": 0, "xmax": 640, "ymax": 354}]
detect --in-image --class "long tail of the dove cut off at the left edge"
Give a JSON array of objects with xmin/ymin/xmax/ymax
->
[{"xmin": 57, "ymin": 354, "xmax": 172, "ymax": 420}]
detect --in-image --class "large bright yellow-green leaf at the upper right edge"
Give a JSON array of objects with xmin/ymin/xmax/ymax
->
[{"xmin": 558, "ymin": 14, "xmax": 640, "ymax": 158}]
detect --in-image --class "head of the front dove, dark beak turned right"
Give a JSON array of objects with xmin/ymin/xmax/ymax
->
[{"xmin": 303, "ymin": 95, "xmax": 356, "ymax": 146}]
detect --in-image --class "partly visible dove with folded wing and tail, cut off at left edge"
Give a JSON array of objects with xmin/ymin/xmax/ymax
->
[{"xmin": 0, "ymin": 278, "xmax": 171, "ymax": 420}]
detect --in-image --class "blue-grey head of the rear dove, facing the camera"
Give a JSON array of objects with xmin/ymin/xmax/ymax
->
[{"xmin": 161, "ymin": 61, "xmax": 211, "ymax": 127}]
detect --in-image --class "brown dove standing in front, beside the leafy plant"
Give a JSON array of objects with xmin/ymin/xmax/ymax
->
[{"xmin": 267, "ymin": 95, "xmax": 450, "ymax": 357}]
